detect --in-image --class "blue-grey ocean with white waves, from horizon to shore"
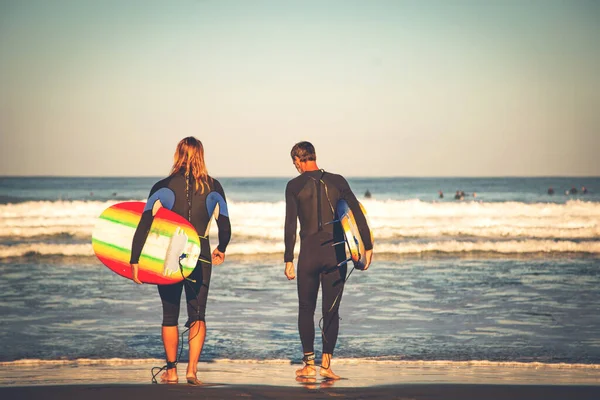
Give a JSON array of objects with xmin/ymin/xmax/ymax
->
[{"xmin": 0, "ymin": 177, "xmax": 600, "ymax": 366}]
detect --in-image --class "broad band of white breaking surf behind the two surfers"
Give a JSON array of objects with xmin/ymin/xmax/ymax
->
[{"xmin": 0, "ymin": 200, "xmax": 600, "ymax": 258}]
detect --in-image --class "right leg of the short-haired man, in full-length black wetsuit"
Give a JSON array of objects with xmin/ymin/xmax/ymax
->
[{"xmin": 320, "ymin": 265, "xmax": 347, "ymax": 379}]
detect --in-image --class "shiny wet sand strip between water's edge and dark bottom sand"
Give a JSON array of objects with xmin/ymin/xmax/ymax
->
[{"xmin": 0, "ymin": 359, "xmax": 600, "ymax": 388}]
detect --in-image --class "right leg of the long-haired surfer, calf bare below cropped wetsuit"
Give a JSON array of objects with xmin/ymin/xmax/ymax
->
[{"xmin": 185, "ymin": 262, "xmax": 212, "ymax": 385}]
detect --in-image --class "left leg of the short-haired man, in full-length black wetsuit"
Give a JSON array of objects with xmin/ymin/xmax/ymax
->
[{"xmin": 296, "ymin": 249, "xmax": 319, "ymax": 376}]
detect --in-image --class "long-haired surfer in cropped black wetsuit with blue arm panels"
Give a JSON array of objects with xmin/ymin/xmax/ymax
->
[{"xmin": 130, "ymin": 137, "xmax": 231, "ymax": 385}]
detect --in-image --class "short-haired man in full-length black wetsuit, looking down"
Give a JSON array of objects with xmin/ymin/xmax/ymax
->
[{"xmin": 284, "ymin": 142, "xmax": 373, "ymax": 379}]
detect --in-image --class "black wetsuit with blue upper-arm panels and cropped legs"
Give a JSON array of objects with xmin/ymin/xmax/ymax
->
[{"xmin": 130, "ymin": 173, "xmax": 231, "ymax": 326}]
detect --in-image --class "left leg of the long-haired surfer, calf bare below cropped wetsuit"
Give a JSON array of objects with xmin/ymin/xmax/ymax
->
[{"xmin": 158, "ymin": 282, "xmax": 183, "ymax": 382}]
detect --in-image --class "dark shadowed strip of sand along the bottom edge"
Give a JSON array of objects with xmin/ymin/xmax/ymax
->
[{"xmin": 0, "ymin": 384, "xmax": 600, "ymax": 400}]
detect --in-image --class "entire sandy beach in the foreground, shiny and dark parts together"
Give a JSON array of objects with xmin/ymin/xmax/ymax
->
[{"xmin": 0, "ymin": 360, "xmax": 600, "ymax": 400}]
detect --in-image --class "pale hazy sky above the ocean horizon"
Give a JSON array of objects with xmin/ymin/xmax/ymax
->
[{"xmin": 0, "ymin": 0, "xmax": 600, "ymax": 177}]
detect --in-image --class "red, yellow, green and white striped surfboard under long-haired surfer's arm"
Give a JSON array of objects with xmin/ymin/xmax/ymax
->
[{"xmin": 92, "ymin": 201, "xmax": 200, "ymax": 285}]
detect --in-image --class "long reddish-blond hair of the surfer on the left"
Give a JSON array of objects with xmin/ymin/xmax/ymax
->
[{"xmin": 171, "ymin": 136, "xmax": 210, "ymax": 193}]
